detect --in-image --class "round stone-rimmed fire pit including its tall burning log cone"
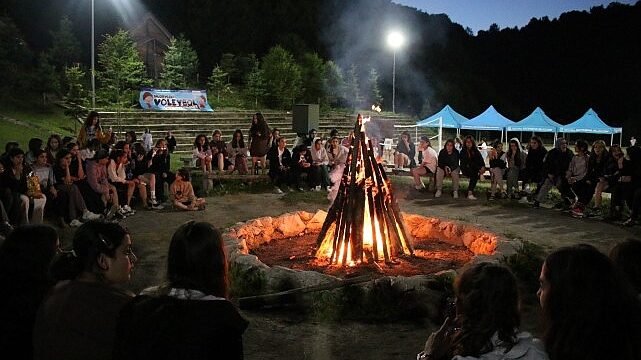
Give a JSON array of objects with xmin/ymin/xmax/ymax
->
[{"xmin": 224, "ymin": 115, "xmax": 515, "ymax": 312}]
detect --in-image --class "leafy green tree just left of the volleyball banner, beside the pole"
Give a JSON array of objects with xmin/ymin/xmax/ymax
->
[{"xmin": 96, "ymin": 30, "xmax": 151, "ymax": 106}]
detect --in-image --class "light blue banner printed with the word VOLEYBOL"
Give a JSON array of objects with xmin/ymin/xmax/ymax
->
[{"xmin": 139, "ymin": 89, "xmax": 214, "ymax": 111}]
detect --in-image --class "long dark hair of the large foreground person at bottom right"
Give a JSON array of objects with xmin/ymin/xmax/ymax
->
[{"xmin": 542, "ymin": 244, "xmax": 641, "ymax": 360}]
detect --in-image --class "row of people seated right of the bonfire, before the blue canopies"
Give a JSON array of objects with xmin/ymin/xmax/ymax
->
[{"xmin": 404, "ymin": 134, "xmax": 641, "ymax": 226}]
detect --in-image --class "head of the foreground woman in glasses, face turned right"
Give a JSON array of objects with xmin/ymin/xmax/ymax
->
[{"xmin": 53, "ymin": 220, "xmax": 137, "ymax": 284}]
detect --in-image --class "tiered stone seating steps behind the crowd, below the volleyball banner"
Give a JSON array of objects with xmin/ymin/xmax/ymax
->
[{"xmin": 100, "ymin": 110, "xmax": 420, "ymax": 155}]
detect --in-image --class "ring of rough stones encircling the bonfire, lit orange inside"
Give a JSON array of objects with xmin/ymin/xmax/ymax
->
[{"xmin": 223, "ymin": 210, "xmax": 521, "ymax": 295}]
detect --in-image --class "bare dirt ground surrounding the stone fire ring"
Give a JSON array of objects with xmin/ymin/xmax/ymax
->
[{"xmin": 64, "ymin": 180, "xmax": 641, "ymax": 359}]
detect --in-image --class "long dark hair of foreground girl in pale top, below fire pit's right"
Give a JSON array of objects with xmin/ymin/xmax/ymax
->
[{"xmin": 453, "ymin": 262, "xmax": 521, "ymax": 357}]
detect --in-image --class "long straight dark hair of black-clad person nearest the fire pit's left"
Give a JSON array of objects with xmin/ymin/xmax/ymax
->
[{"xmin": 167, "ymin": 220, "xmax": 227, "ymax": 298}]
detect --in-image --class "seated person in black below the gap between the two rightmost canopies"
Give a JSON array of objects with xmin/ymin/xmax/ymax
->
[{"xmin": 533, "ymin": 138, "xmax": 574, "ymax": 208}]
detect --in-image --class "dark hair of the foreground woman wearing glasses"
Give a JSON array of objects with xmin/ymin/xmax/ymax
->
[{"xmin": 52, "ymin": 220, "xmax": 129, "ymax": 281}]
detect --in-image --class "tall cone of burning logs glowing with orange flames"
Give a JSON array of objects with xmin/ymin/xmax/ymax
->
[{"xmin": 316, "ymin": 114, "xmax": 414, "ymax": 266}]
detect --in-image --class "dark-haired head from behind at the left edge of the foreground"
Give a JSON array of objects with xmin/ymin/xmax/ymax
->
[{"xmin": 0, "ymin": 225, "xmax": 60, "ymax": 291}]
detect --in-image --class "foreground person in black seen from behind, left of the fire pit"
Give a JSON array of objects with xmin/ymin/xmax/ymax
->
[{"xmin": 113, "ymin": 221, "xmax": 248, "ymax": 360}]
